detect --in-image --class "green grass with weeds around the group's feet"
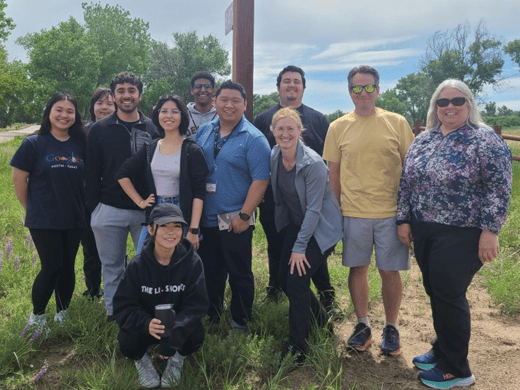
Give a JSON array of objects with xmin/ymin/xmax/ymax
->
[{"xmin": 0, "ymin": 129, "xmax": 520, "ymax": 390}]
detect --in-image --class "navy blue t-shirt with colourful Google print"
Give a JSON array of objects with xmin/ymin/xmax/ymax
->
[{"xmin": 9, "ymin": 134, "xmax": 85, "ymax": 229}]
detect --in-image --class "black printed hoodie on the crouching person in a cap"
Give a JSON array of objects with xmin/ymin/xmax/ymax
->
[{"xmin": 114, "ymin": 238, "xmax": 209, "ymax": 349}]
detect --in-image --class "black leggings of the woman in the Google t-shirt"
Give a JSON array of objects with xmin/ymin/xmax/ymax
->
[{"xmin": 29, "ymin": 229, "xmax": 83, "ymax": 315}]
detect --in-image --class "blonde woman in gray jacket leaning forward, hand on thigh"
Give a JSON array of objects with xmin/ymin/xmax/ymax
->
[{"xmin": 271, "ymin": 108, "xmax": 342, "ymax": 362}]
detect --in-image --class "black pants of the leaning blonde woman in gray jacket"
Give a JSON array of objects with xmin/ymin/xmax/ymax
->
[{"xmin": 279, "ymin": 224, "xmax": 330, "ymax": 352}]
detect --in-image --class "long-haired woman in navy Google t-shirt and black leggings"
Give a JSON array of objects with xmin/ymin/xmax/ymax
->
[{"xmin": 10, "ymin": 93, "xmax": 86, "ymax": 340}]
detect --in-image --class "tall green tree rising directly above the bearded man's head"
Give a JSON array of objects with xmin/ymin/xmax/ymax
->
[{"xmin": 81, "ymin": 3, "xmax": 152, "ymax": 86}]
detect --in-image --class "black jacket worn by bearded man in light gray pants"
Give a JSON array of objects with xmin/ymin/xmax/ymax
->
[{"xmin": 85, "ymin": 112, "xmax": 159, "ymax": 212}]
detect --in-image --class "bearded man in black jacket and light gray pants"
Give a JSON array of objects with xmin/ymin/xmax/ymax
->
[{"xmin": 85, "ymin": 72, "xmax": 158, "ymax": 316}]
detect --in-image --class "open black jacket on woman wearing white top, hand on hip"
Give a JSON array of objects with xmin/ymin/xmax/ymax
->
[{"xmin": 116, "ymin": 138, "xmax": 209, "ymax": 224}]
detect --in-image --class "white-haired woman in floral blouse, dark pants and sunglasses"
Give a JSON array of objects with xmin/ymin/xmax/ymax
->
[{"xmin": 397, "ymin": 80, "xmax": 512, "ymax": 389}]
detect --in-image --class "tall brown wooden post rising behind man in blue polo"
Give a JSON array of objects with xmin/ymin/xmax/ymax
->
[{"xmin": 232, "ymin": 0, "xmax": 255, "ymax": 122}]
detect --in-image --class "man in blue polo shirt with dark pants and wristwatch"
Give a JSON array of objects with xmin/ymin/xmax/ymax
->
[{"xmin": 195, "ymin": 80, "xmax": 270, "ymax": 330}]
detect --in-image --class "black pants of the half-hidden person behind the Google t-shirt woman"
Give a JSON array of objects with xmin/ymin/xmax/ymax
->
[{"xmin": 81, "ymin": 213, "xmax": 101, "ymax": 297}]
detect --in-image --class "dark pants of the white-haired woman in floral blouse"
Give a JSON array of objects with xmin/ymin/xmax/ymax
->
[{"xmin": 412, "ymin": 222, "xmax": 482, "ymax": 378}]
